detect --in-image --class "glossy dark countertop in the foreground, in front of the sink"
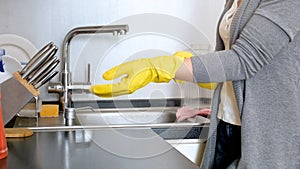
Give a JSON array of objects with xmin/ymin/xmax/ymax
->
[{"xmin": 0, "ymin": 128, "xmax": 199, "ymax": 169}]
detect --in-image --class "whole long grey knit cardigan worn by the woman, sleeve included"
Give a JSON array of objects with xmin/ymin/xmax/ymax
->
[{"xmin": 192, "ymin": 0, "xmax": 300, "ymax": 169}]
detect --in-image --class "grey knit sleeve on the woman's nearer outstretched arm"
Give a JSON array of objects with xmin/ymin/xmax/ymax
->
[{"xmin": 192, "ymin": 0, "xmax": 300, "ymax": 83}]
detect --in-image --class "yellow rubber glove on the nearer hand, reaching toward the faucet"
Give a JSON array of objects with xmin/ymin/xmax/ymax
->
[{"xmin": 90, "ymin": 52, "xmax": 184, "ymax": 97}]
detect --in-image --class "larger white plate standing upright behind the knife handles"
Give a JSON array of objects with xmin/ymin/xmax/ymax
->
[{"xmin": 0, "ymin": 34, "xmax": 37, "ymax": 63}]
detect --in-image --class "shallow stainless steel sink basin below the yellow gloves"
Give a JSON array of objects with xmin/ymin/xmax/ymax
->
[{"xmin": 76, "ymin": 108, "xmax": 209, "ymax": 126}]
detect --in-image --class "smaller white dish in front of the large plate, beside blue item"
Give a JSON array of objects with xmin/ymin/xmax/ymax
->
[{"xmin": 2, "ymin": 55, "xmax": 22, "ymax": 74}]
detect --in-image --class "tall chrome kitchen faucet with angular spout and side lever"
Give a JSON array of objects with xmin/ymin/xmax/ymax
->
[{"xmin": 48, "ymin": 25, "xmax": 129, "ymax": 125}]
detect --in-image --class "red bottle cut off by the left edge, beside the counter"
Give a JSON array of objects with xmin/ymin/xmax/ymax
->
[{"xmin": 0, "ymin": 90, "xmax": 8, "ymax": 159}]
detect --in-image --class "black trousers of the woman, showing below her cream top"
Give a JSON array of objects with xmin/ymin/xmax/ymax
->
[{"xmin": 214, "ymin": 120, "xmax": 241, "ymax": 169}]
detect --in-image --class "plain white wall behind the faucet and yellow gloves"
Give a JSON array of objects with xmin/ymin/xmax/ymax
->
[{"xmin": 0, "ymin": 0, "xmax": 225, "ymax": 101}]
